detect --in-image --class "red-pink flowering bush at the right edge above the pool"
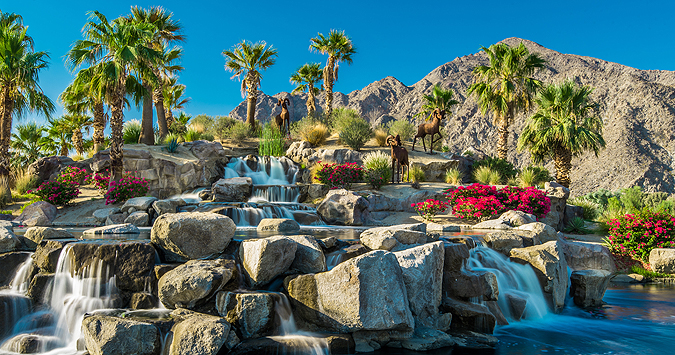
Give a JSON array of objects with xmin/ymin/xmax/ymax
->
[{"xmin": 605, "ymin": 209, "xmax": 675, "ymax": 262}]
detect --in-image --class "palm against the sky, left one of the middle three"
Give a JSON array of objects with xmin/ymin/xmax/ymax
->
[{"xmin": 223, "ymin": 41, "xmax": 279, "ymax": 128}]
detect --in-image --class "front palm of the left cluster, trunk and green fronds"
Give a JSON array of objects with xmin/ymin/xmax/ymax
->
[{"xmin": 68, "ymin": 11, "xmax": 160, "ymax": 183}]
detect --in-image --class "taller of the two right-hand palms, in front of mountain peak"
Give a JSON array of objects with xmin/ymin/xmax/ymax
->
[{"xmin": 467, "ymin": 42, "xmax": 546, "ymax": 159}]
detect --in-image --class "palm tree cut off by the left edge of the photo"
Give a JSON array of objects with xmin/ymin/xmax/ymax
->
[{"xmin": 0, "ymin": 13, "xmax": 54, "ymax": 185}]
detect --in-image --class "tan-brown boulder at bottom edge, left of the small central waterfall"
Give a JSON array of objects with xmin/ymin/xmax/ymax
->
[{"xmin": 167, "ymin": 310, "xmax": 239, "ymax": 355}]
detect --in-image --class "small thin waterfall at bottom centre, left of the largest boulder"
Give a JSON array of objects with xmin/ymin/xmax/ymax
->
[{"xmin": 271, "ymin": 293, "xmax": 330, "ymax": 355}]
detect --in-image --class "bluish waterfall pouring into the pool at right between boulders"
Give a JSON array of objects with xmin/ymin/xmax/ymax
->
[{"xmin": 466, "ymin": 246, "xmax": 549, "ymax": 322}]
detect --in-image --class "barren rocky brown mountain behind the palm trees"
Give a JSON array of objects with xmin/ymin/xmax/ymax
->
[{"xmin": 230, "ymin": 38, "xmax": 675, "ymax": 195}]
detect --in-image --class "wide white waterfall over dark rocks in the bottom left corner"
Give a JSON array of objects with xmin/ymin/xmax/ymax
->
[{"xmin": 0, "ymin": 244, "xmax": 118, "ymax": 355}]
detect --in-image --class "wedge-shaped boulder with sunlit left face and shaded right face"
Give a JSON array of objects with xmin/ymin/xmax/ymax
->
[{"xmin": 239, "ymin": 236, "xmax": 298, "ymax": 286}]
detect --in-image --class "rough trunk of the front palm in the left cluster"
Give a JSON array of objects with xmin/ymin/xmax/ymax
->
[{"xmin": 110, "ymin": 80, "xmax": 126, "ymax": 188}]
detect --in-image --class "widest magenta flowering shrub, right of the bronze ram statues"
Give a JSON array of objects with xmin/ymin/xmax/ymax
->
[{"xmin": 445, "ymin": 184, "xmax": 551, "ymax": 220}]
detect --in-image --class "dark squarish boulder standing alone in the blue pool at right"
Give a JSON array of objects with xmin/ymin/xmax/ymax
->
[{"xmin": 570, "ymin": 270, "xmax": 612, "ymax": 307}]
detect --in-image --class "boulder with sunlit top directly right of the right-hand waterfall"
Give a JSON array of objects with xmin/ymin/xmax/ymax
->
[{"xmin": 511, "ymin": 241, "xmax": 569, "ymax": 312}]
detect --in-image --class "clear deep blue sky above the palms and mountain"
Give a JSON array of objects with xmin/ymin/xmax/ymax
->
[{"xmin": 0, "ymin": 0, "xmax": 675, "ymax": 128}]
